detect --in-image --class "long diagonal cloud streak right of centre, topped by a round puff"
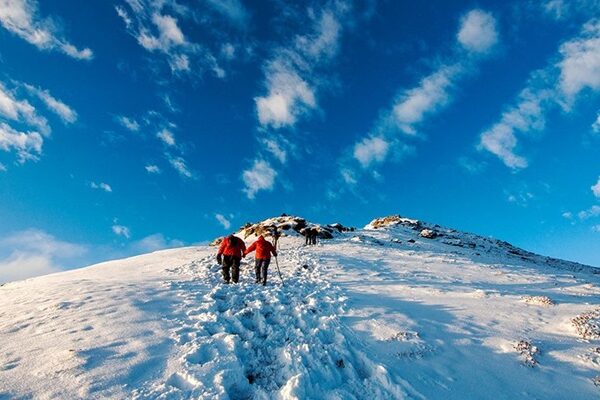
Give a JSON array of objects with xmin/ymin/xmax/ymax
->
[{"xmin": 340, "ymin": 9, "xmax": 499, "ymax": 189}]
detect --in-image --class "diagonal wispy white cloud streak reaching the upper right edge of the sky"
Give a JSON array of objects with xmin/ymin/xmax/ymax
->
[{"xmin": 479, "ymin": 21, "xmax": 600, "ymax": 170}]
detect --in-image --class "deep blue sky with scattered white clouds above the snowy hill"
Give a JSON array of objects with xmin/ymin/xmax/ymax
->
[{"xmin": 0, "ymin": 0, "xmax": 600, "ymax": 281}]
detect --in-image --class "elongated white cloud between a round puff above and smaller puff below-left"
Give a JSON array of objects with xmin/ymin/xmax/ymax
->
[{"xmin": 392, "ymin": 64, "xmax": 463, "ymax": 135}]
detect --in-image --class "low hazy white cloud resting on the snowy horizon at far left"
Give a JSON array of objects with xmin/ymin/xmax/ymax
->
[{"xmin": 0, "ymin": 229, "xmax": 88, "ymax": 282}]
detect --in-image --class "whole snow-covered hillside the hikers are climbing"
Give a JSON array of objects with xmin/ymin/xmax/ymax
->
[{"xmin": 0, "ymin": 217, "xmax": 600, "ymax": 399}]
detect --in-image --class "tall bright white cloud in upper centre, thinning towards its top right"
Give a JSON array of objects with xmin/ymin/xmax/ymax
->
[{"xmin": 254, "ymin": 9, "xmax": 345, "ymax": 129}]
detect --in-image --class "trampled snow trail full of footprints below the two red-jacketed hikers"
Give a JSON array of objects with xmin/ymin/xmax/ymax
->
[{"xmin": 134, "ymin": 248, "xmax": 405, "ymax": 400}]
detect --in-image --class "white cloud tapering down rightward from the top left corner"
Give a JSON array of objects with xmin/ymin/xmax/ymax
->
[{"xmin": 0, "ymin": 0, "xmax": 93, "ymax": 60}]
